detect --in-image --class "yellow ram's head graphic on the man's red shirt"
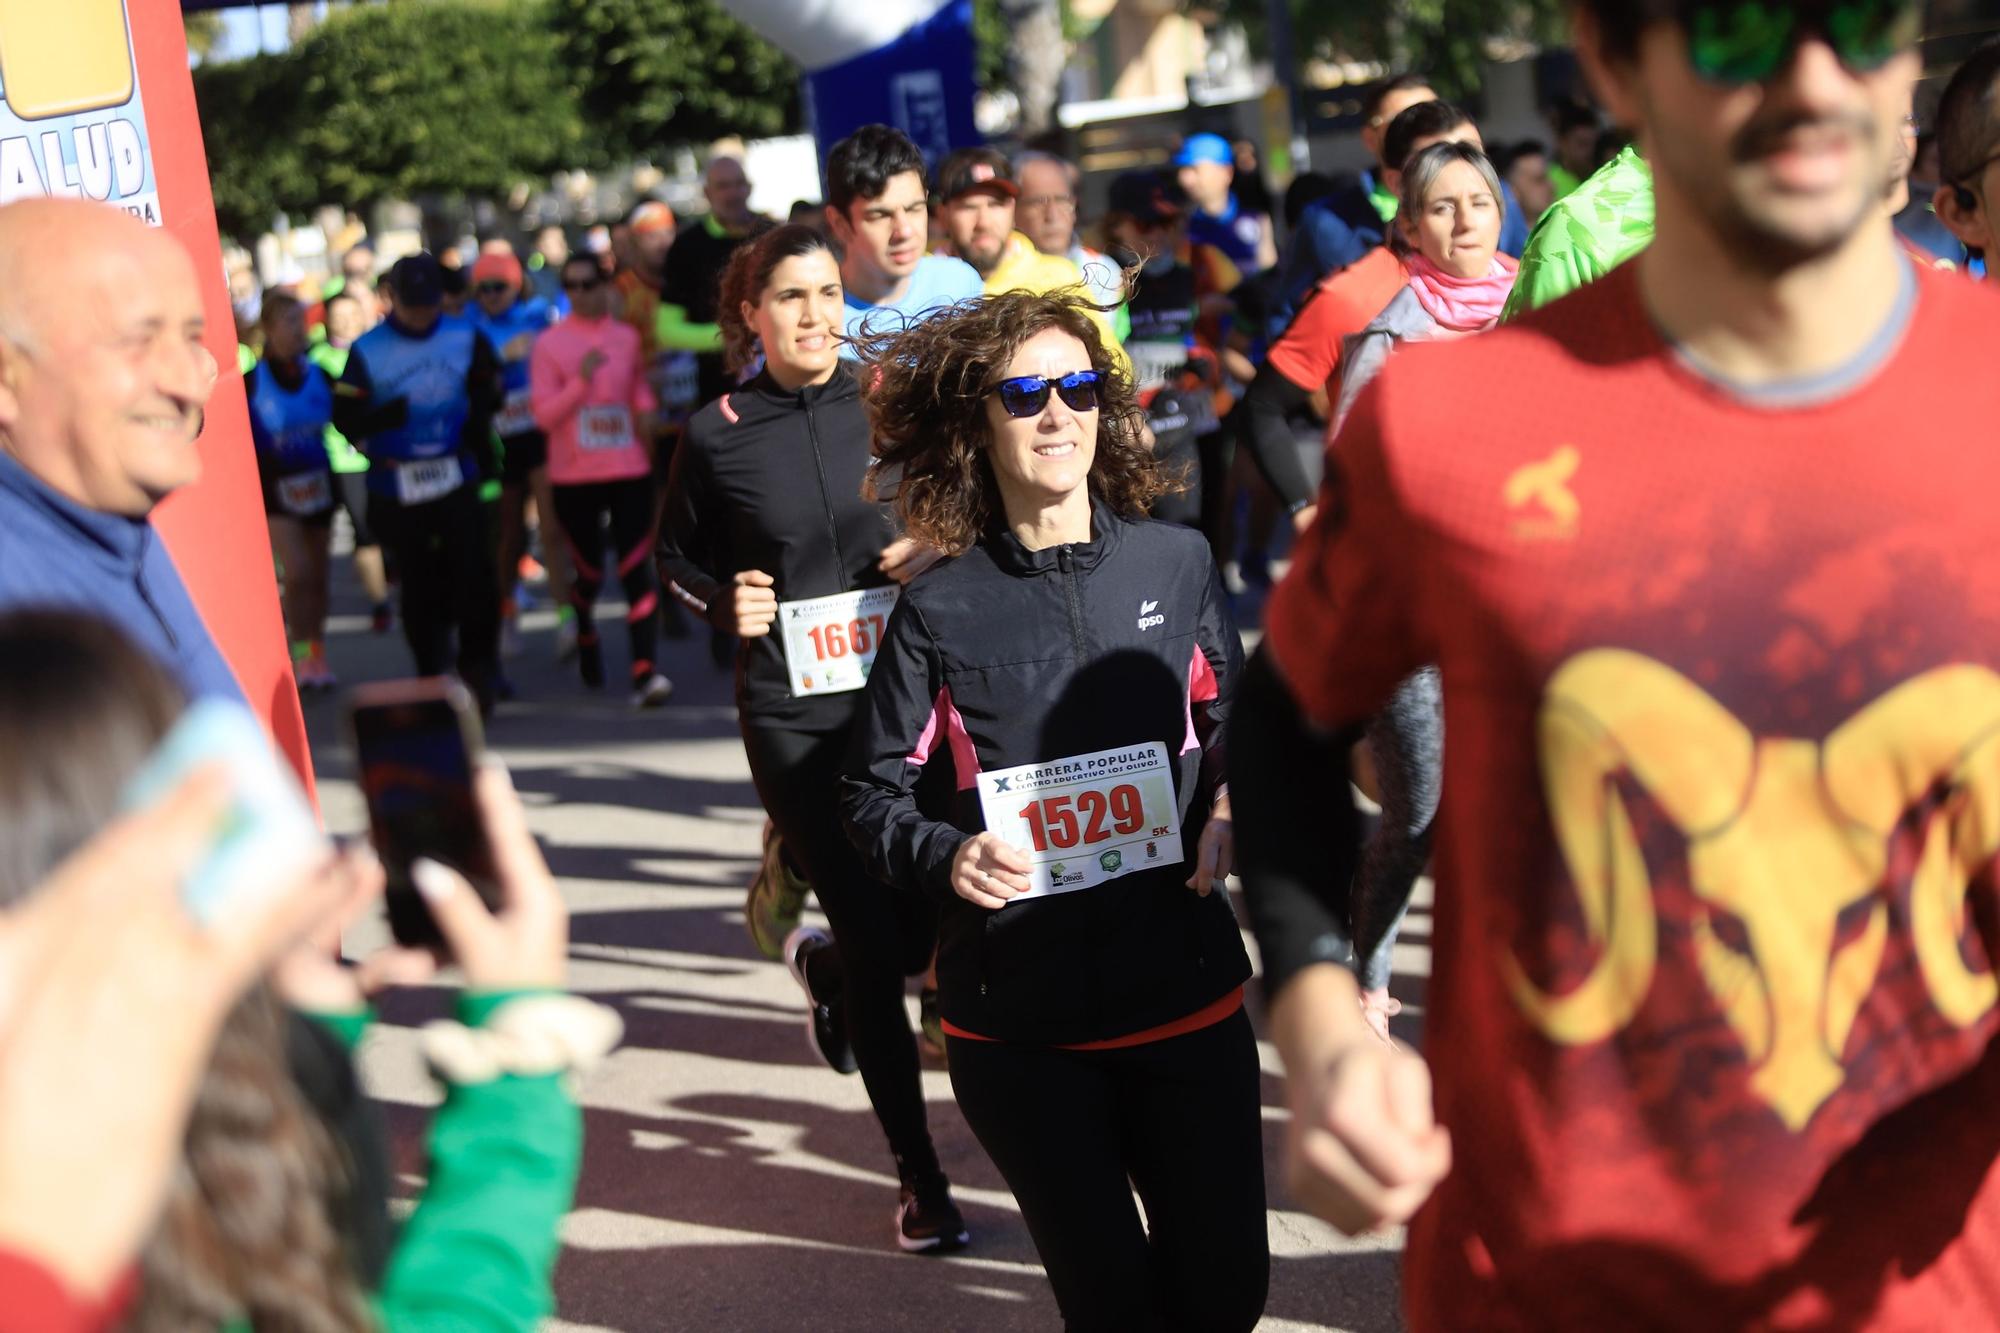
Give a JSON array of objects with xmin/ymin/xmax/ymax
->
[{"xmin": 1506, "ymin": 648, "xmax": 2000, "ymax": 1131}]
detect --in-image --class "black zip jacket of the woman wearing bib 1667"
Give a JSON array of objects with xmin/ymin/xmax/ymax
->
[{"xmin": 658, "ymin": 362, "xmax": 896, "ymax": 731}]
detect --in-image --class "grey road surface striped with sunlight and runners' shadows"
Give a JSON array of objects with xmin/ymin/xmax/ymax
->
[{"xmin": 306, "ymin": 536, "xmax": 1430, "ymax": 1333}]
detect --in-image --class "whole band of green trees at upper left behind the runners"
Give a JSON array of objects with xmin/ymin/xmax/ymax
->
[{"xmin": 194, "ymin": 0, "xmax": 798, "ymax": 240}]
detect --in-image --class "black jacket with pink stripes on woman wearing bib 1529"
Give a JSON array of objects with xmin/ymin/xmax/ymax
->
[{"xmin": 840, "ymin": 504, "xmax": 1250, "ymax": 1043}]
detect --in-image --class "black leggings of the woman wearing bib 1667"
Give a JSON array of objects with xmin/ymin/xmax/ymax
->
[{"xmin": 742, "ymin": 716, "xmax": 938, "ymax": 1181}]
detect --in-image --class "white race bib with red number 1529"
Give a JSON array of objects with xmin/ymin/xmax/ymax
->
[{"xmin": 980, "ymin": 741, "xmax": 1180, "ymax": 899}]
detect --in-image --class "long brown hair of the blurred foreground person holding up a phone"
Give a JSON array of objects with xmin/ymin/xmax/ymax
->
[{"xmin": 0, "ymin": 610, "xmax": 374, "ymax": 1333}]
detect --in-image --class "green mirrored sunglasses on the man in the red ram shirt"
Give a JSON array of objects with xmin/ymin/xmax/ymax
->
[{"xmin": 1672, "ymin": 0, "xmax": 1924, "ymax": 86}]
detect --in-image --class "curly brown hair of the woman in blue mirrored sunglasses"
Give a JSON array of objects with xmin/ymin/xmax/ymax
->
[{"xmin": 858, "ymin": 292, "xmax": 1182, "ymax": 554}]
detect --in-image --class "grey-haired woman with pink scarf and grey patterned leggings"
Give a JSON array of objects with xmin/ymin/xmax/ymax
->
[{"xmin": 1328, "ymin": 142, "xmax": 1516, "ymax": 1041}]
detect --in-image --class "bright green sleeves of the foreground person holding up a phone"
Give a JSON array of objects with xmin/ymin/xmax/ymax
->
[{"xmin": 230, "ymin": 991, "xmax": 584, "ymax": 1333}]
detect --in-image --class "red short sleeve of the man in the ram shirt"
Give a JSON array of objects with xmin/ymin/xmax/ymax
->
[{"xmin": 1266, "ymin": 374, "xmax": 1436, "ymax": 727}]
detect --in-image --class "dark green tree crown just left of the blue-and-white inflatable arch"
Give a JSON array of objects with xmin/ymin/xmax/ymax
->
[{"xmin": 548, "ymin": 0, "xmax": 800, "ymax": 156}]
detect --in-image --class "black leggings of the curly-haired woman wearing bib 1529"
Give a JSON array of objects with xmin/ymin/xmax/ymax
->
[{"xmin": 946, "ymin": 1009, "xmax": 1270, "ymax": 1333}]
